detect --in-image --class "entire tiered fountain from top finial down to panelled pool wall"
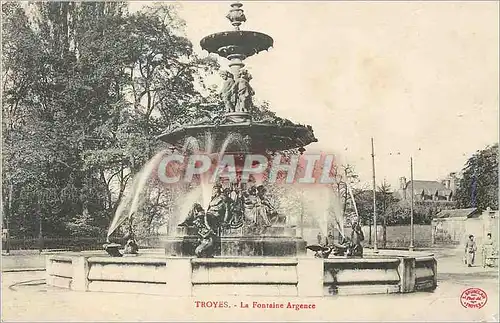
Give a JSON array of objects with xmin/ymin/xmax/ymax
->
[{"xmin": 46, "ymin": 3, "xmax": 437, "ymax": 297}]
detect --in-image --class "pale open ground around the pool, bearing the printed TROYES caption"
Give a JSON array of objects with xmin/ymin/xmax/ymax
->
[{"xmin": 2, "ymin": 250, "xmax": 499, "ymax": 322}]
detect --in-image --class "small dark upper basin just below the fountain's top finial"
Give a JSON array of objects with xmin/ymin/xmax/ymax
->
[{"xmin": 200, "ymin": 30, "xmax": 274, "ymax": 58}]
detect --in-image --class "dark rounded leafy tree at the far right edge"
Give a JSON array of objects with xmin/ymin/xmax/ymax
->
[{"xmin": 456, "ymin": 143, "xmax": 498, "ymax": 210}]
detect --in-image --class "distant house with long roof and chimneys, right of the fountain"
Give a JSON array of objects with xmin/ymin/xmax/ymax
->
[{"xmin": 396, "ymin": 173, "xmax": 456, "ymax": 202}]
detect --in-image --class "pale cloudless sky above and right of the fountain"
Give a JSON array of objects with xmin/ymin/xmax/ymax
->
[{"xmin": 131, "ymin": 1, "xmax": 499, "ymax": 188}]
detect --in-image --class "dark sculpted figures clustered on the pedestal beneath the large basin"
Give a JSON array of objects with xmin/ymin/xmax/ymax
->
[{"xmin": 179, "ymin": 184, "xmax": 280, "ymax": 257}]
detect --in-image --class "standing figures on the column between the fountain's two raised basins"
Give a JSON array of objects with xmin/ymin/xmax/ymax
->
[{"xmin": 220, "ymin": 70, "xmax": 255, "ymax": 113}]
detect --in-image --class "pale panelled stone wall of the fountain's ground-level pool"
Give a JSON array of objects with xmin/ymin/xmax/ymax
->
[{"xmin": 46, "ymin": 250, "xmax": 437, "ymax": 297}]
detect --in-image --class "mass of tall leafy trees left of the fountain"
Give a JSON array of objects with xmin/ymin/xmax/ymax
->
[{"xmin": 2, "ymin": 2, "xmax": 217, "ymax": 240}]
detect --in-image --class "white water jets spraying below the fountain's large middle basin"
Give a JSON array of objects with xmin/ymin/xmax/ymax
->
[{"xmin": 108, "ymin": 132, "xmax": 350, "ymax": 246}]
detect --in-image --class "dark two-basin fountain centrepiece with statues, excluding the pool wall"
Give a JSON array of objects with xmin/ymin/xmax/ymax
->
[{"xmin": 159, "ymin": 3, "xmax": 317, "ymax": 256}]
